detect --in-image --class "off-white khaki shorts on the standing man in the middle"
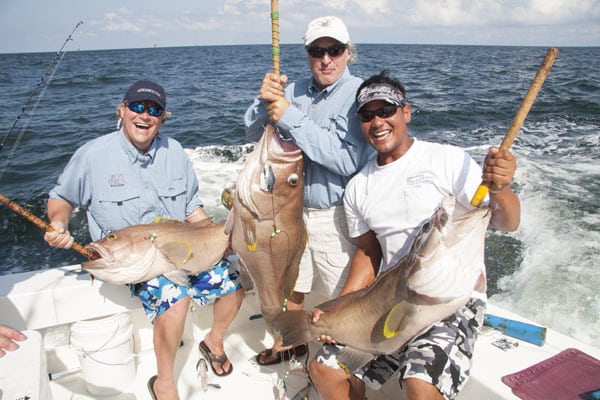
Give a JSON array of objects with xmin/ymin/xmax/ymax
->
[{"xmin": 294, "ymin": 206, "xmax": 356, "ymax": 298}]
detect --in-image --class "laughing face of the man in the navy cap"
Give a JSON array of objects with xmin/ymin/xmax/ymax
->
[{"xmin": 119, "ymin": 101, "xmax": 165, "ymax": 153}]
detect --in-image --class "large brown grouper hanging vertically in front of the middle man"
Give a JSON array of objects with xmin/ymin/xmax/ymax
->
[{"xmin": 226, "ymin": 125, "xmax": 306, "ymax": 325}]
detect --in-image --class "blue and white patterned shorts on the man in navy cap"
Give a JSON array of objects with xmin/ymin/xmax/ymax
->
[{"xmin": 132, "ymin": 259, "xmax": 242, "ymax": 322}]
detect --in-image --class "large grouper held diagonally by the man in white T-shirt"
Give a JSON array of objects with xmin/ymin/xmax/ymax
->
[{"xmin": 273, "ymin": 197, "xmax": 491, "ymax": 367}]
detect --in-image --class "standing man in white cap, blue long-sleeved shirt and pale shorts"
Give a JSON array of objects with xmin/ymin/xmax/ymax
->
[{"xmin": 244, "ymin": 16, "xmax": 374, "ymax": 365}]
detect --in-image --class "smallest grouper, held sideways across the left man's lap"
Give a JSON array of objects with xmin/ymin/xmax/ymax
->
[{"xmin": 82, "ymin": 219, "xmax": 229, "ymax": 285}]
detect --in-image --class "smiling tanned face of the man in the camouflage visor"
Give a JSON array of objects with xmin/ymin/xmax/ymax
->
[{"xmin": 361, "ymin": 100, "xmax": 413, "ymax": 165}]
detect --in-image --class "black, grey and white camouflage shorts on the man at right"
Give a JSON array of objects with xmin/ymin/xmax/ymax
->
[{"xmin": 316, "ymin": 298, "xmax": 486, "ymax": 400}]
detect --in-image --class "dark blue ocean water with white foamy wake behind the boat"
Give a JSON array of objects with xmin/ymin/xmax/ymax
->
[{"xmin": 0, "ymin": 44, "xmax": 600, "ymax": 346}]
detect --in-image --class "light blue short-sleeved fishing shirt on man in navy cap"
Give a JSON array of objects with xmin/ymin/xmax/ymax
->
[{"xmin": 50, "ymin": 130, "xmax": 202, "ymax": 241}]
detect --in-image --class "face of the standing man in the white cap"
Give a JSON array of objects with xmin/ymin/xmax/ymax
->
[{"xmin": 306, "ymin": 37, "xmax": 351, "ymax": 90}]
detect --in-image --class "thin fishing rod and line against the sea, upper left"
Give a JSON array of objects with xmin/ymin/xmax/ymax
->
[{"xmin": 0, "ymin": 21, "xmax": 83, "ymax": 180}]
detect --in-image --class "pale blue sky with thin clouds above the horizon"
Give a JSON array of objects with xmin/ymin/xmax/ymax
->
[{"xmin": 0, "ymin": 0, "xmax": 600, "ymax": 53}]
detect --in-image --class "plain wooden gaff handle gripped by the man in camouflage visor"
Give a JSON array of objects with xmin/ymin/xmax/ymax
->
[{"xmin": 471, "ymin": 47, "xmax": 558, "ymax": 207}]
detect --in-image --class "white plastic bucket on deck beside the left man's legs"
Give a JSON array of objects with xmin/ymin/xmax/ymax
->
[{"xmin": 71, "ymin": 313, "xmax": 135, "ymax": 396}]
